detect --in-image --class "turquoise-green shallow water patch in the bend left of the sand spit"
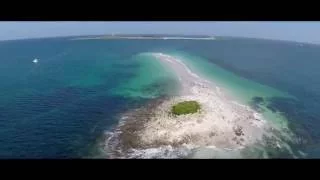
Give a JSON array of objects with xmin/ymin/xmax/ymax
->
[{"xmin": 113, "ymin": 53, "xmax": 178, "ymax": 98}]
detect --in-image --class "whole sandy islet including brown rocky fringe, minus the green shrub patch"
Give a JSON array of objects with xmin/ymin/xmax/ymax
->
[{"xmin": 107, "ymin": 53, "xmax": 296, "ymax": 158}]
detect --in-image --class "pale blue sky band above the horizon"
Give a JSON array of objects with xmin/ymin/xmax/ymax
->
[{"xmin": 0, "ymin": 21, "xmax": 320, "ymax": 43}]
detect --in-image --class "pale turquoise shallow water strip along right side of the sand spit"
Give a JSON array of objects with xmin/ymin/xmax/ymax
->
[{"xmin": 172, "ymin": 52, "xmax": 296, "ymax": 128}]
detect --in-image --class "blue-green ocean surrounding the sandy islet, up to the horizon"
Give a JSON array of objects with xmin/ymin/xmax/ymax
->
[{"xmin": 0, "ymin": 37, "xmax": 320, "ymax": 158}]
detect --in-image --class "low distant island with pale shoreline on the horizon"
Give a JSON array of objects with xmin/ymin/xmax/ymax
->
[{"xmin": 72, "ymin": 34, "xmax": 215, "ymax": 40}]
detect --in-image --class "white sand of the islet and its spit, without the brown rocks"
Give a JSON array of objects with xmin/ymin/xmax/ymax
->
[{"xmin": 135, "ymin": 53, "xmax": 267, "ymax": 149}]
